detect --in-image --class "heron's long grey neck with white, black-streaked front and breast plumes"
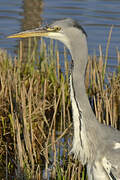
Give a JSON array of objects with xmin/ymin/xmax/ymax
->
[{"xmin": 66, "ymin": 32, "xmax": 102, "ymax": 164}]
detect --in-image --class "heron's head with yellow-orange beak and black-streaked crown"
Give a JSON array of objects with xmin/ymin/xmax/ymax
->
[{"xmin": 8, "ymin": 19, "xmax": 86, "ymax": 49}]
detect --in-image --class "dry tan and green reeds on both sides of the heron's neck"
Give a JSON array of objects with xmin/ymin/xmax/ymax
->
[{"xmin": 0, "ymin": 39, "xmax": 120, "ymax": 180}]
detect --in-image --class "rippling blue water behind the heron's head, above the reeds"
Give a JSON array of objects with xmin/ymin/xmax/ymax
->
[{"xmin": 0, "ymin": 0, "xmax": 120, "ymax": 65}]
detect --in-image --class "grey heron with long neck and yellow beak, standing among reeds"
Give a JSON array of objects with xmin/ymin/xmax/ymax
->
[{"xmin": 9, "ymin": 19, "xmax": 120, "ymax": 180}]
